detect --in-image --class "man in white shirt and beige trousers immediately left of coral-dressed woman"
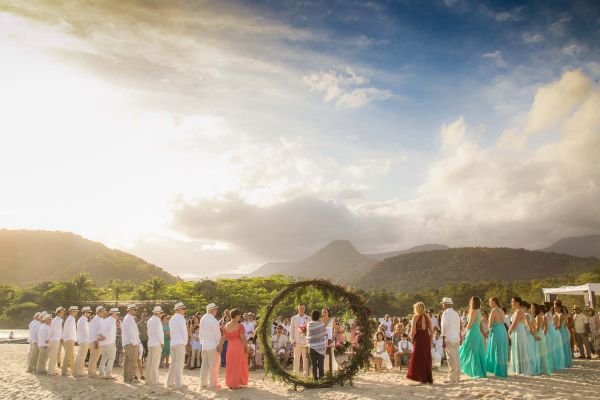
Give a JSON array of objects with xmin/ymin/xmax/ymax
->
[{"xmin": 200, "ymin": 303, "xmax": 221, "ymax": 388}]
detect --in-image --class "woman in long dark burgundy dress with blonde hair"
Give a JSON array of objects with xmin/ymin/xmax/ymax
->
[{"xmin": 406, "ymin": 302, "xmax": 433, "ymax": 383}]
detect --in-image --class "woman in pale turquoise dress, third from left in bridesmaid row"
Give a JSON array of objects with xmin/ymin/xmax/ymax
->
[{"xmin": 508, "ymin": 297, "xmax": 531, "ymax": 375}]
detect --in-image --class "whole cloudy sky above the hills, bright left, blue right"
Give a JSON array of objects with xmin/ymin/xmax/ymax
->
[{"xmin": 0, "ymin": 0, "xmax": 600, "ymax": 279}]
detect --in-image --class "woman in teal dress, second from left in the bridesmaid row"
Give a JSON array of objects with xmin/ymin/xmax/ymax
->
[{"xmin": 485, "ymin": 297, "xmax": 508, "ymax": 378}]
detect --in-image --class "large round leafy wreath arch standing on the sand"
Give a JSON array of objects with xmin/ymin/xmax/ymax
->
[{"xmin": 258, "ymin": 279, "xmax": 373, "ymax": 389}]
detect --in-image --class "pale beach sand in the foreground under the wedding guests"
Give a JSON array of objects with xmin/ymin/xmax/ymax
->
[{"xmin": 0, "ymin": 344, "xmax": 600, "ymax": 400}]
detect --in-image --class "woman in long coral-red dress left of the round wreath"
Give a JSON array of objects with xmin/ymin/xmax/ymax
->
[{"xmin": 221, "ymin": 308, "xmax": 248, "ymax": 389}]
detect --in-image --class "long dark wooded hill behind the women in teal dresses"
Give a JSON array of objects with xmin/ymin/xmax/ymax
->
[{"xmin": 355, "ymin": 247, "xmax": 600, "ymax": 292}]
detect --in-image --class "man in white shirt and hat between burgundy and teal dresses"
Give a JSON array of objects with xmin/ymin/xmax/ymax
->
[{"xmin": 442, "ymin": 297, "xmax": 461, "ymax": 383}]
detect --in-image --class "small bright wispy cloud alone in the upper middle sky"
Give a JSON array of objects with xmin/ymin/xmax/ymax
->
[{"xmin": 302, "ymin": 67, "xmax": 392, "ymax": 108}]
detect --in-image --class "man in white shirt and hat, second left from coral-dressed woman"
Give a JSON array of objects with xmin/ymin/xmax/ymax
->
[{"xmin": 167, "ymin": 303, "xmax": 188, "ymax": 389}]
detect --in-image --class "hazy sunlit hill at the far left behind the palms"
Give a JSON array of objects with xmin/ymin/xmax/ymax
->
[{"xmin": 0, "ymin": 229, "xmax": 178, "ymax": 286}]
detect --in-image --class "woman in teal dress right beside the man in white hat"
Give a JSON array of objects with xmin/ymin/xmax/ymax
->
[{"xmin": 458, "ymin": 296, "xmax": 486, "ymax": 378}]
